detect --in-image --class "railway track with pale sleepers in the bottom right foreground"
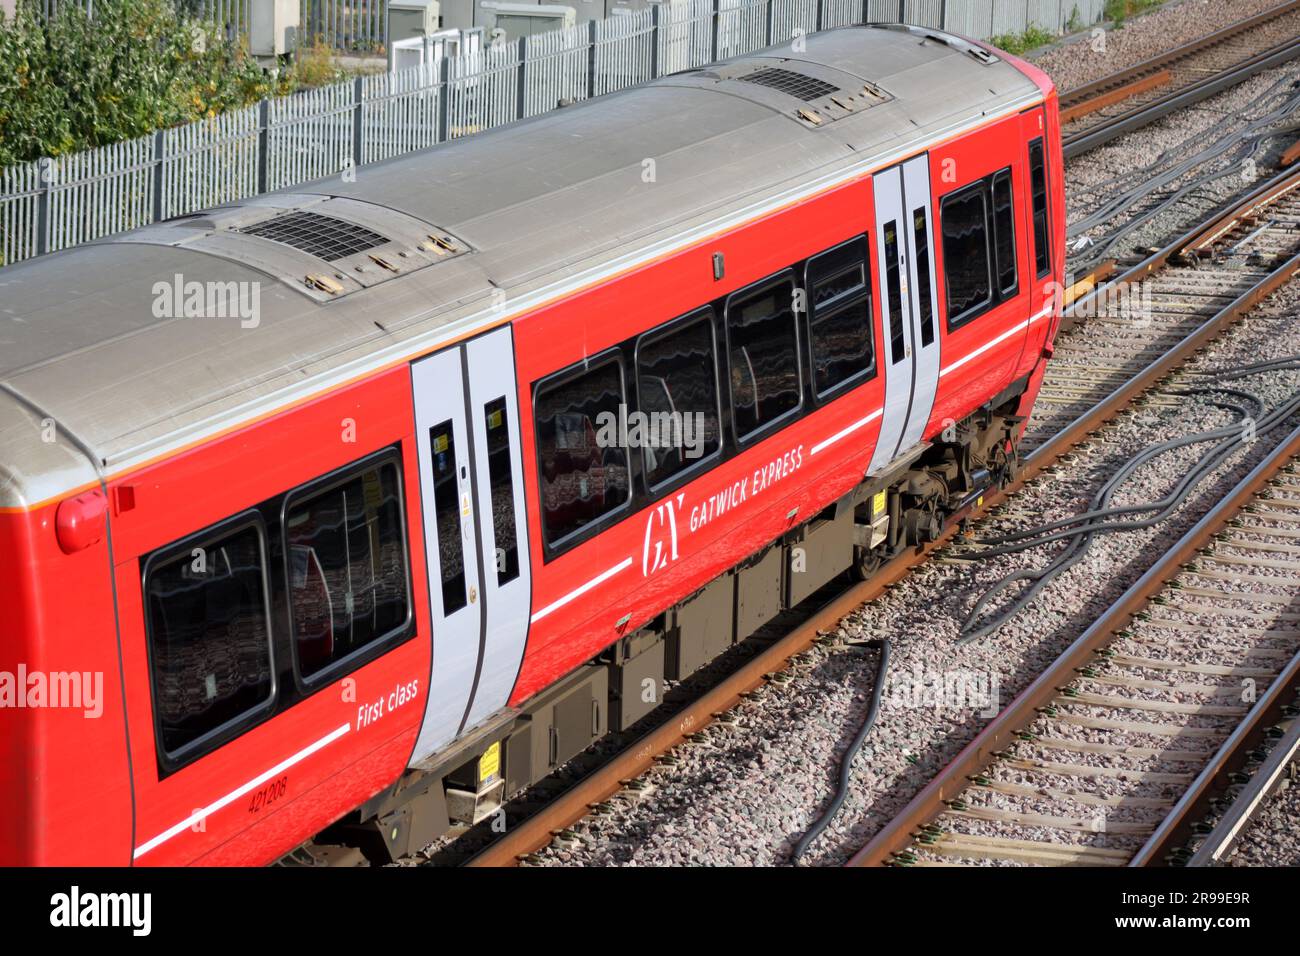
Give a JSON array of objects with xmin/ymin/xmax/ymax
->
[{"xmin": 850, "ymin": 437, "xmax": 1300, "ymax": 866}]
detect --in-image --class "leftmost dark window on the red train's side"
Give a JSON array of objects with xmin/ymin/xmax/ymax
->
[{"xmin": 144, "ymin": 523, "xmax": 274, "ymax": 756}]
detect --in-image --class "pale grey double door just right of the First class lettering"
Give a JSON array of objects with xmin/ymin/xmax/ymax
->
[{"xmin": 411, "ymin": 325, "xmax": 530, "ymax": 763}]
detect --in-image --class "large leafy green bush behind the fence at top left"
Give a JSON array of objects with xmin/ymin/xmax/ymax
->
[{"xmin": 0, "ymin": 0, "xmax": 289, "ymax": 165}]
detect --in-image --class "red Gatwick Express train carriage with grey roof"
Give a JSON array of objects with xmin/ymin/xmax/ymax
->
[{"xmin": 0, "ymin": 27, "xmax": 1063, "ymax": 864}]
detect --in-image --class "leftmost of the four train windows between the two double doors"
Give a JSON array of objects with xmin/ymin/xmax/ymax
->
[{"xmin": 536, "ymin": 359, "xmax": 631, "ymax": 544}]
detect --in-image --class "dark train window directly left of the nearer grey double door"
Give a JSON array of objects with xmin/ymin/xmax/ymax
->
[{"xmin": 285, "ymin": 463, "xmax": 410, "ymax": 679}]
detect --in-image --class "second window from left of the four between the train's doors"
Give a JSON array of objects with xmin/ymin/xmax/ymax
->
[{"xmin": 637, "ymin": 311, "xmax": 722, "ymax": 488}]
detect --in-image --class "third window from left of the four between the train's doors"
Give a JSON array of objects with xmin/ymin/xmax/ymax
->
[{"xmin": 727, "ymin": 278, "xmax": 801, "ymax": 440}]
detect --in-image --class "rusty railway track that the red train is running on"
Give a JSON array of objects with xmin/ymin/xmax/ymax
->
[{"xmin": 454, "ymin": 162, "xmax": 1300, "ymax": 866}]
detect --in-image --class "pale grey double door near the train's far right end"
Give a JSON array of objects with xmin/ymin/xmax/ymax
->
[{"xmin": 870, "ymin": 156, "xmax": 939, "ymax": 472}]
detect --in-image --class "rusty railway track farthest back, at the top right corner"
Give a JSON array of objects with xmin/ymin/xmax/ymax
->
[{"xmin": 1061, "ymin": 1, "xmax": 1300, "ymax": 159}]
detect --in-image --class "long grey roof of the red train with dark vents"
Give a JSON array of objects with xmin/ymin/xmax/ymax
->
[{"xmin": 0, "ymin": 27, "xmax": 1044, "ymax": 507}]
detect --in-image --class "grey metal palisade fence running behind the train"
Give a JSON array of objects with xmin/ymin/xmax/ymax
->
[{"xmin": 0, "ymin": 0, "xmax": 1104, "ymax": 264}]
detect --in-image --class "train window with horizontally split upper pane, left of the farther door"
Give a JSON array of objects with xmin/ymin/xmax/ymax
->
[{"xmin": 807, "ymin": 239, "xmax": 875, "ymax": 398}]
